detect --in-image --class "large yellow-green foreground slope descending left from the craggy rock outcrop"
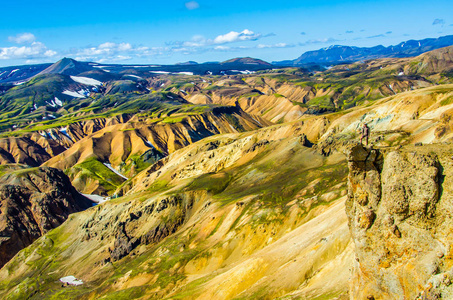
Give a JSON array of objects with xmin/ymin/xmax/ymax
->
[{"xmin": 0, "ymin": 121, "xmax": 352, "ymax": 299}]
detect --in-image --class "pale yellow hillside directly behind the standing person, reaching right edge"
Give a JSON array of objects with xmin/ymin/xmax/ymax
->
[{"xmin": 316, "ymin": 85, "xmax": 453, "ymax": 146}]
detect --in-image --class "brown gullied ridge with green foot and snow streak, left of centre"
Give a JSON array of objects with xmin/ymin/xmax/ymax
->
[{"xmin": 41, "ymin": 107, "xmax": 266, "ymax": 194}]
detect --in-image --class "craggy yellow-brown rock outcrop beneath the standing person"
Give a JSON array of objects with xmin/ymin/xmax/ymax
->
[{"xmin": 346, "ymin": 145, "xmax": 453, "ymax": 299}]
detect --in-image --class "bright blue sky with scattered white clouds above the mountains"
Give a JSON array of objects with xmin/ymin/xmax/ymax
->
[{"xmin": 0, "ymin": 0, "xmax": 453, "ymax": 66}]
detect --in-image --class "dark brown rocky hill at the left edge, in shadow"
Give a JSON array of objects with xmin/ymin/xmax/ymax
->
[{"xmin": 0, "ymin": 167, "xmax": 92, "ymax": 267}]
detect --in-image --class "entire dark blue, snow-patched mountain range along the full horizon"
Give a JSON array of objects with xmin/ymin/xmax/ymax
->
[{"xmin": 0, "ymin": 35, "xmax": 453, "ymax": 84}]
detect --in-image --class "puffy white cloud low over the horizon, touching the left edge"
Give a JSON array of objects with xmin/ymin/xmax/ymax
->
[{"xmin": 0, "ymin": 42, "xmax": 57, "ymax": 60}]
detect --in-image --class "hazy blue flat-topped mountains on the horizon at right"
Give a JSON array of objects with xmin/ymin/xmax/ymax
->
[{"xmin": 273, "ymin": 35, "xmax": 453, "ymax": 66}]
